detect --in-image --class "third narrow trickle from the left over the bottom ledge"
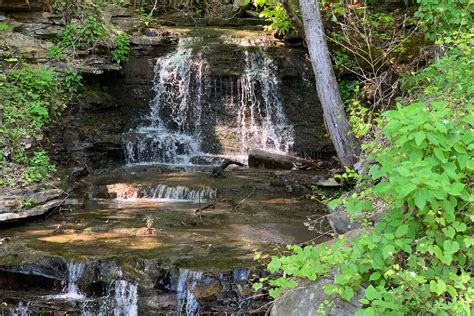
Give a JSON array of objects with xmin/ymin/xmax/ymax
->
[{"xmin": 177, "ymin": 270, "xmax": 203, "ymax": 316}]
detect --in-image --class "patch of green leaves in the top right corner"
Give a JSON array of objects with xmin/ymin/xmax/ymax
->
[{"xmin": 415, "ymin": 0, "xmax": 474, "ymax": 40}]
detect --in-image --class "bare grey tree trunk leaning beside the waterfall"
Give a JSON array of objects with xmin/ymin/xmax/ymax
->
[{"xmin": 300, "ymin": 0, "xmax": 360, "ymax": 166}]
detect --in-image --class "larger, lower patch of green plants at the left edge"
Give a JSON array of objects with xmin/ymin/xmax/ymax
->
[{"xmin": 0, "ymin": 65, "xmax": 72, "ymax": 185}]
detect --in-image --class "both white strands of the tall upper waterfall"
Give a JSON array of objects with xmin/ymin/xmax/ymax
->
[{"xmin": 125, "ymin": 38, "xmax": 293, "ymax": 165}]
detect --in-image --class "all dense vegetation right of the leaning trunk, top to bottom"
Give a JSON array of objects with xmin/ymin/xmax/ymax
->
[{"xmin": 255, "ymin": 1, "xmax": 474, "ymax": 315}]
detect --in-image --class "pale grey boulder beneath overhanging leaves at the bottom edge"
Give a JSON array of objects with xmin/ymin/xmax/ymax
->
[{"xmin": 271, "ymin": 278, "xmax": 363, "ymax": 316}]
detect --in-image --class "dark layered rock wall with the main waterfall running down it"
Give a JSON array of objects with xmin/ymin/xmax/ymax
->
[{"xmin": 46, "ymin": 28, "xmax": 332, "ymax": 168}]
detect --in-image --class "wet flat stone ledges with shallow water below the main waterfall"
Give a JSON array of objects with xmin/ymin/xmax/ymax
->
[{"xmin": 0, "ymin": 166, "xmax": 330, "ymax": 315}]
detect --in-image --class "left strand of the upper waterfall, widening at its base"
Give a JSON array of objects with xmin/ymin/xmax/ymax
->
[{"xmin": 126, "ymin": 38, "xmax": 205, "ymax": 164}]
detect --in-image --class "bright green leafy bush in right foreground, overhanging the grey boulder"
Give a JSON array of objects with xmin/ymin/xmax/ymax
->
[{"xmin": 260, "ymin": 35, "xmax": 474, "ymax": 315}]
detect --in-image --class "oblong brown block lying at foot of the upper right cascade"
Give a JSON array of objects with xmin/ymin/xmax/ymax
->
[{"xmin": 249, "ymin": 149, "xmax": 314, "ymax": 169}]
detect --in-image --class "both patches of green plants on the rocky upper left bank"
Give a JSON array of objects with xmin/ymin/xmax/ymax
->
[{"xmin": 0, "ymin": 1, "xmax": 130, "ymax": 186}]
